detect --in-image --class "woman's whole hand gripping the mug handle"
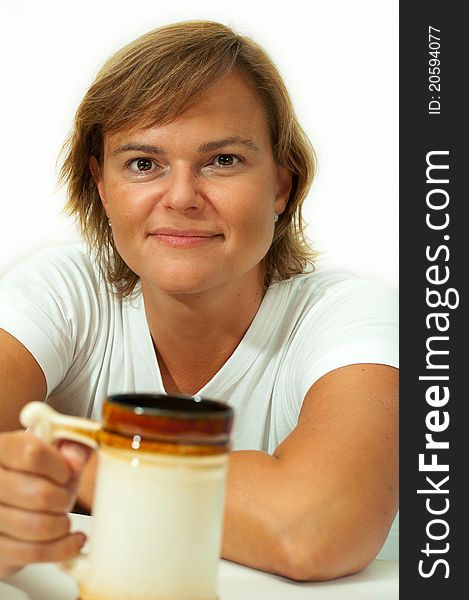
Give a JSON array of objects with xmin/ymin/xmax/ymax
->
[{"xmin": 0, "ymin": 431, "xmax": 92, "ymax": 579}]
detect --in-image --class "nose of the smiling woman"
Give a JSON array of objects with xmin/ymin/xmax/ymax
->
[{"xmin": 162, "ymin": 165, "xmax": 204, "ymax": 214}]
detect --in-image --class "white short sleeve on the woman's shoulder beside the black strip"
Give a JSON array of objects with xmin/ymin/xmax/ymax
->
[{"xmin": 287, "ymin": 278, "xmax": 399, "ymax": 425}]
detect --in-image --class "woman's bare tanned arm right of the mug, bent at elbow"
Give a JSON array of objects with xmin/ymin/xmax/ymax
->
[{"xmin": 223, "ymin": 364, "xmax": 398, "ymax": 580}]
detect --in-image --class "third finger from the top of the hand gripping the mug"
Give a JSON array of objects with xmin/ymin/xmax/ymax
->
[{"xmin": 0, "ymin": 504, "xmax": 70, "ymax": 542}]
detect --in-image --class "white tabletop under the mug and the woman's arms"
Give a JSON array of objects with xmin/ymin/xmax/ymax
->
[{"xmin": 0, "ymin": 514, "xmax": 399, "ymax": 600}]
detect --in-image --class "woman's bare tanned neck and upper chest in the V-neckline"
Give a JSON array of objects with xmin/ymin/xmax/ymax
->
[{"xmin": 142, "ymin": 272, "xmax": 263, "ymax": 394}]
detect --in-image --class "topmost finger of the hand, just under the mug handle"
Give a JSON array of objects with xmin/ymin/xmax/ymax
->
[{"xmin": 0, "ymin": 431, "xmax": 72, "ymax": 485}]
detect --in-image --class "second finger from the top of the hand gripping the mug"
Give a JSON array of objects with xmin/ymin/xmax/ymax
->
[{"xmin": 0, "ymin": 467, "xmax": 74, "ymax": 513}]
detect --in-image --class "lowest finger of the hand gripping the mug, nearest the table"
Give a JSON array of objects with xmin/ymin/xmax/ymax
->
[{"xmin": 0, "ymin": 531, "xmax": 86, "ymax": 568}]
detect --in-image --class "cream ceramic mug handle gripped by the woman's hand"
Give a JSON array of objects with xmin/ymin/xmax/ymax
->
[{"xmin": 20, "ymin": 402, "xmax": 101, "ymax": 583}]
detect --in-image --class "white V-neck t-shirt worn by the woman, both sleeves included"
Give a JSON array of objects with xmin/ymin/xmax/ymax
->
[{"xmin": 0, "ymin": 244, "xmax": 398, "ymax": 556}]
